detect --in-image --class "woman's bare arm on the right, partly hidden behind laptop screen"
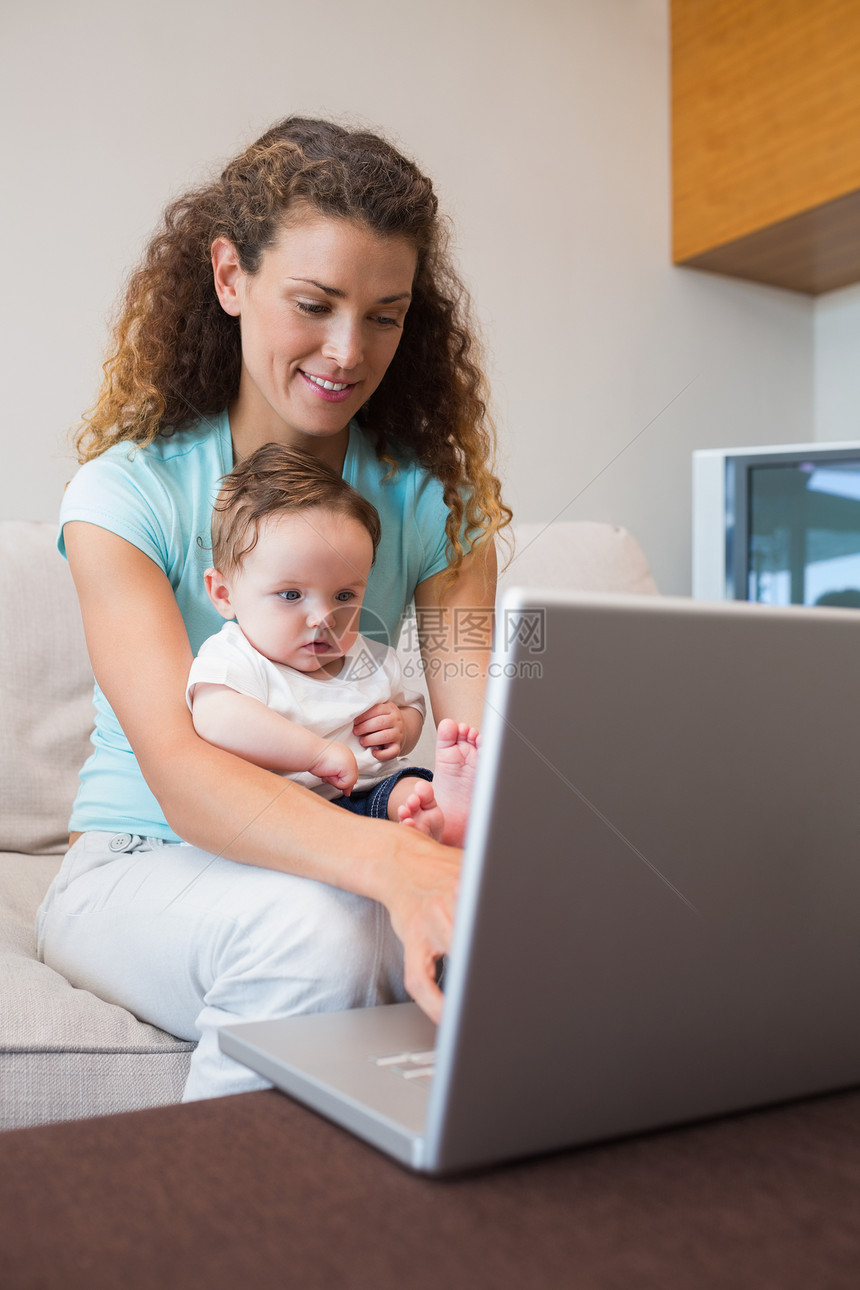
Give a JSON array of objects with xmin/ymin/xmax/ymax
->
[{"xmin": 415, "ymin": 542, "xmax": 498, "ymax": 729}]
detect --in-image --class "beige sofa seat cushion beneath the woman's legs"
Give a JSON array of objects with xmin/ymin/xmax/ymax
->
[{"xmin": 0, "ymin": 854, "xmax": 193, "ymax": 1129}]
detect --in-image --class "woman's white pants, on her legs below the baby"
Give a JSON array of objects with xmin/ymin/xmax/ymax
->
[{"xmin": 36, "ymin": 833, "xmax": 406, "ymax": 1102}]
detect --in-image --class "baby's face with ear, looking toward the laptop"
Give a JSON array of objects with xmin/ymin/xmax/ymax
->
[{"xmin": 208, "ymin": 507, "xmax": 373, "ymax": 676}]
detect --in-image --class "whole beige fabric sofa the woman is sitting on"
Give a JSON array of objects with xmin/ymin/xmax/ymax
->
[{"xmin": 0, "ymin": 520, "xmax": 656, "ymax": 1129}]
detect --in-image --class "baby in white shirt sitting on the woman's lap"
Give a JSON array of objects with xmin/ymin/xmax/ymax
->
[{"xmin": 187, "ymin": 444, "xmax": 478, "ymax": 846}]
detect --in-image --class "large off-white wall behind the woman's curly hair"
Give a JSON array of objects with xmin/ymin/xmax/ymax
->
[{"xmin": 0, "ymin": 0, "xmax": 820, "ymax": 592}]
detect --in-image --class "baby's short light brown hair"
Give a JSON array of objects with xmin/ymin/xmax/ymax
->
[{"xmin": 211, "ymin": 444, "xmax": 382, "ymax": 574}]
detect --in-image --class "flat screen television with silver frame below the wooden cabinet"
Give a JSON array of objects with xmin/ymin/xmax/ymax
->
[{"xmin": 692, "ymin": 442, "xmax": 860, "ymax": 608}]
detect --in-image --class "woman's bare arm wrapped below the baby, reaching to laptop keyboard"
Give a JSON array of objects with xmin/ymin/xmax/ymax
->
[{"xmin": 63, "ymin": 520, "xmax": 460, "ymax": 1020}]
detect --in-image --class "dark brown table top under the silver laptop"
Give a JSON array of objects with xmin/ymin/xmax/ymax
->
[{"xmin": 0, "ymin": 1091, "xmax": 860, "ymax": 1290}]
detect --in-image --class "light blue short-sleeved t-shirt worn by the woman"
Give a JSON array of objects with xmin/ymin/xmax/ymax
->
[{"xmin": 58, "ymin": 412, "xmax": 456, "ymax": 841}]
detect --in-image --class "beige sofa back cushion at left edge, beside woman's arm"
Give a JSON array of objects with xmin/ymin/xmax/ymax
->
[{"xmin": 0, "ymin": 520, "xmax": 93, "ymax": 854}]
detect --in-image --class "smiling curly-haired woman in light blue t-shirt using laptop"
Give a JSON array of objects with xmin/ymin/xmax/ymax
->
[{"xmin": 39, "ymin": 117, "xmax": 509, "ymax": 1099}]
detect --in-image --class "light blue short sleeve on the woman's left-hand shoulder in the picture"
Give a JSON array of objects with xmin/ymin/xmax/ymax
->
[{"xmin": 57, "ymin": 444, "xmax": 173, "ymax": 573}]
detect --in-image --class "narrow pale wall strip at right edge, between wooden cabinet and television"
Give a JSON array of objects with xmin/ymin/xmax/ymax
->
[{"xmin": 815, "ymin": 286, "xmax": 860, "ymax": 442}]
